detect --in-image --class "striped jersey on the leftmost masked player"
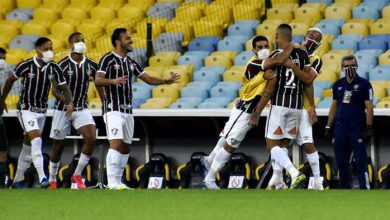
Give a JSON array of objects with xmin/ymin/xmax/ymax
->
[{"xmin": 14, "ymin": 56, "xmax": 66, "ymax": 112}]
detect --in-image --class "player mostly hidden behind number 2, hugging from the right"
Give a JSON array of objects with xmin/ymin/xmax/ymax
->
[{"xmin": 297, "ymin": 28, "xmax": 324, "ymax": 190}]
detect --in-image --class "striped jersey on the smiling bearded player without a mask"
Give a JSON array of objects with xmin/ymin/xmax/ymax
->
[{"xmin": 98, "ymin": 51, "xmax": 144, "ymax": 114}]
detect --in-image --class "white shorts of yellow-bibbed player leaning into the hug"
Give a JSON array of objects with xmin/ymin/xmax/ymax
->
[{"xmin": 220, "ymin": 108, "xmax": 252, "ymax": 148}]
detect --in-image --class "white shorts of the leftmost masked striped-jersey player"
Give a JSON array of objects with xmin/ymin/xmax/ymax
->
[{"xmin": 18, "ymin": 110, "xmax": 46, "ymax": 134}]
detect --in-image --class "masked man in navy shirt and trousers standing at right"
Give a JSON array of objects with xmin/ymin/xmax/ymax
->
[{"xmin": 325, "ymin": 55, "xmax": 373, "ymax": 189}]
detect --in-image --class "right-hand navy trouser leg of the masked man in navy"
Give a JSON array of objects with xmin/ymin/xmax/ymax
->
[{"xmin": 348, "ymin": 132, "xmax": 370, "ymax": 189}]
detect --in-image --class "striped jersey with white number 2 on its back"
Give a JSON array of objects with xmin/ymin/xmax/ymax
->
[{"xmin": 270, "ymin": 48, "xmax": 310, "ymax": 109}]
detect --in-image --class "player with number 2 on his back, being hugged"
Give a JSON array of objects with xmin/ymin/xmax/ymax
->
[{"xmin": 251, "ymin": 24, "xmax": 314, "ymax": 189}]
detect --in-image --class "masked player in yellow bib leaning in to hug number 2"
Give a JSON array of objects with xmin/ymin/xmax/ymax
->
[{"xmin": 201, "ymin": 36, "xmax": 293, "ymax": 189}]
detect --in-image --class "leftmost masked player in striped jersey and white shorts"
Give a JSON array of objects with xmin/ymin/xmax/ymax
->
[{"xmin": 0, "ymin": 37, "xmax": 73, "ymax": 188}]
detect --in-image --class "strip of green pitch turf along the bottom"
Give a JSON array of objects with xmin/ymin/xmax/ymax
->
[{"xmin": 0, "ymin": 189, "xmax": 390, "ymax": 220}]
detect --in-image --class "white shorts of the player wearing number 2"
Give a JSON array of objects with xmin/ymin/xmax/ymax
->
[{"xmin": 265, "ymin": 105, "xmax": 302, "ymax": 140}]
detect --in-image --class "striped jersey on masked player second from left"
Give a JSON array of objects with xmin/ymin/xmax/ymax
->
[{"xmin": 57, "ymin": 55, "xmax": 98, "ymax": 111}]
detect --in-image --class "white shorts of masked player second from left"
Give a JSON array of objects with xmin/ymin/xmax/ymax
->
[{"xmin": 50, "ymin": 109, "xmax": 95, "ymax": 140}]
